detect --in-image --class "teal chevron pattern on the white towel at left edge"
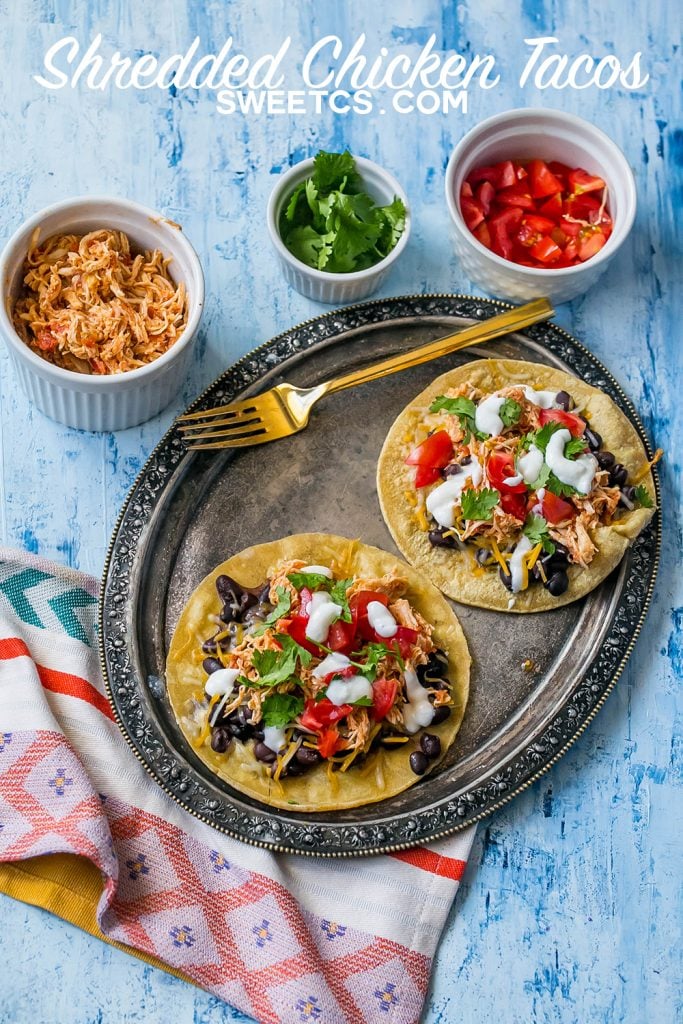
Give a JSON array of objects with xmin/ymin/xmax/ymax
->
[{"xmin": 0, "ymin": 567, "xmax": 97, "ymax": 647}]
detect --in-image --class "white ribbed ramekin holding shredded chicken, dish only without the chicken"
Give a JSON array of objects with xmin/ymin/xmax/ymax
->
[{"xmin": 0, "ymin": 196, "xmax": 204, "ymax": 430}]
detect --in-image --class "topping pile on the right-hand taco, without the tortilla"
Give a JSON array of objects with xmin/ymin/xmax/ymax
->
[{"xmin": 405, "ymin": 383, "xmax": 652, "ymax": 600}]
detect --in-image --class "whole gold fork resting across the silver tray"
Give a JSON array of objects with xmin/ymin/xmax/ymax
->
[{"xmin": 176, "ymin": 299, "xmax": 554, "ymax": 451}]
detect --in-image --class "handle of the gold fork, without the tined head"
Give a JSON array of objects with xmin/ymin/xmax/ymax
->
[{"xmin": 316, "ymin": 299, "xmax": 555, "ymax": 397}]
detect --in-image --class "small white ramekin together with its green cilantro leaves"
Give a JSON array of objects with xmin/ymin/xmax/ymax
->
[{"xmin": 267, "ymin": 151, "xmax": 410, "ymax": 303}]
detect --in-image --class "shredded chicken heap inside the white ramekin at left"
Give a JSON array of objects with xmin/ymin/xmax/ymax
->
[{"xmin": 11, "ymin": 227, "xmax": 188, "ymax": 375}]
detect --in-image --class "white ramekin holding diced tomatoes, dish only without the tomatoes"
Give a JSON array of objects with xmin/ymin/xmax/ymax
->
[{"xmin": 445, "ymin": 110, "xmax": 636, "ymax": 303}]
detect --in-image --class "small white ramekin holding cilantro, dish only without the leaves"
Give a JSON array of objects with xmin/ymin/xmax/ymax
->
[{"xmin": 266, "ymin": 157, "xmax": 411, "ymax": 305}]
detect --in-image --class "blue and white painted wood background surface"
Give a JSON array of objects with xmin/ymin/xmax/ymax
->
[{"xmin": 0, "ymin": 0, "xmax": 683, "ymax": 1024}]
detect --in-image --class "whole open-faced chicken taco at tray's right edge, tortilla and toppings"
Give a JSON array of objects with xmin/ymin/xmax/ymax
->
[{"xmin": 377, "ymin": 359, "xmax": 655, "ymax": 612}]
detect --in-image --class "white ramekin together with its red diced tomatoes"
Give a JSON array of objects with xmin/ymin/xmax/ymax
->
[{"xmin": 445, "ymin": 110, "xmax": 636, "ymax": 302}]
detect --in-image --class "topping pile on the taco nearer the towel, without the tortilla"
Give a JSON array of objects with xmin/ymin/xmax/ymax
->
[{"xmin": 197, "ymin": 560, "xmax": 452, "ymax": 779}]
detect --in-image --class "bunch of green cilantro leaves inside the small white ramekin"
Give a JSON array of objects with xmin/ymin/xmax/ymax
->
[{"xmin": 279, "ymin": 151, "xmax": 405, "ymax": 273}]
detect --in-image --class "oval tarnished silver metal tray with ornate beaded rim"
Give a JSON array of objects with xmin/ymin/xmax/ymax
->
[{"xmin": 100, "ymin": 295, "xmax": 660, "ymax": 856}]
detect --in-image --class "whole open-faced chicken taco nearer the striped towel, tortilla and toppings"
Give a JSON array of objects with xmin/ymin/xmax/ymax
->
[{"xmin": 166, "ymin": 534, "xmax": 470, "ymax": 811}]
